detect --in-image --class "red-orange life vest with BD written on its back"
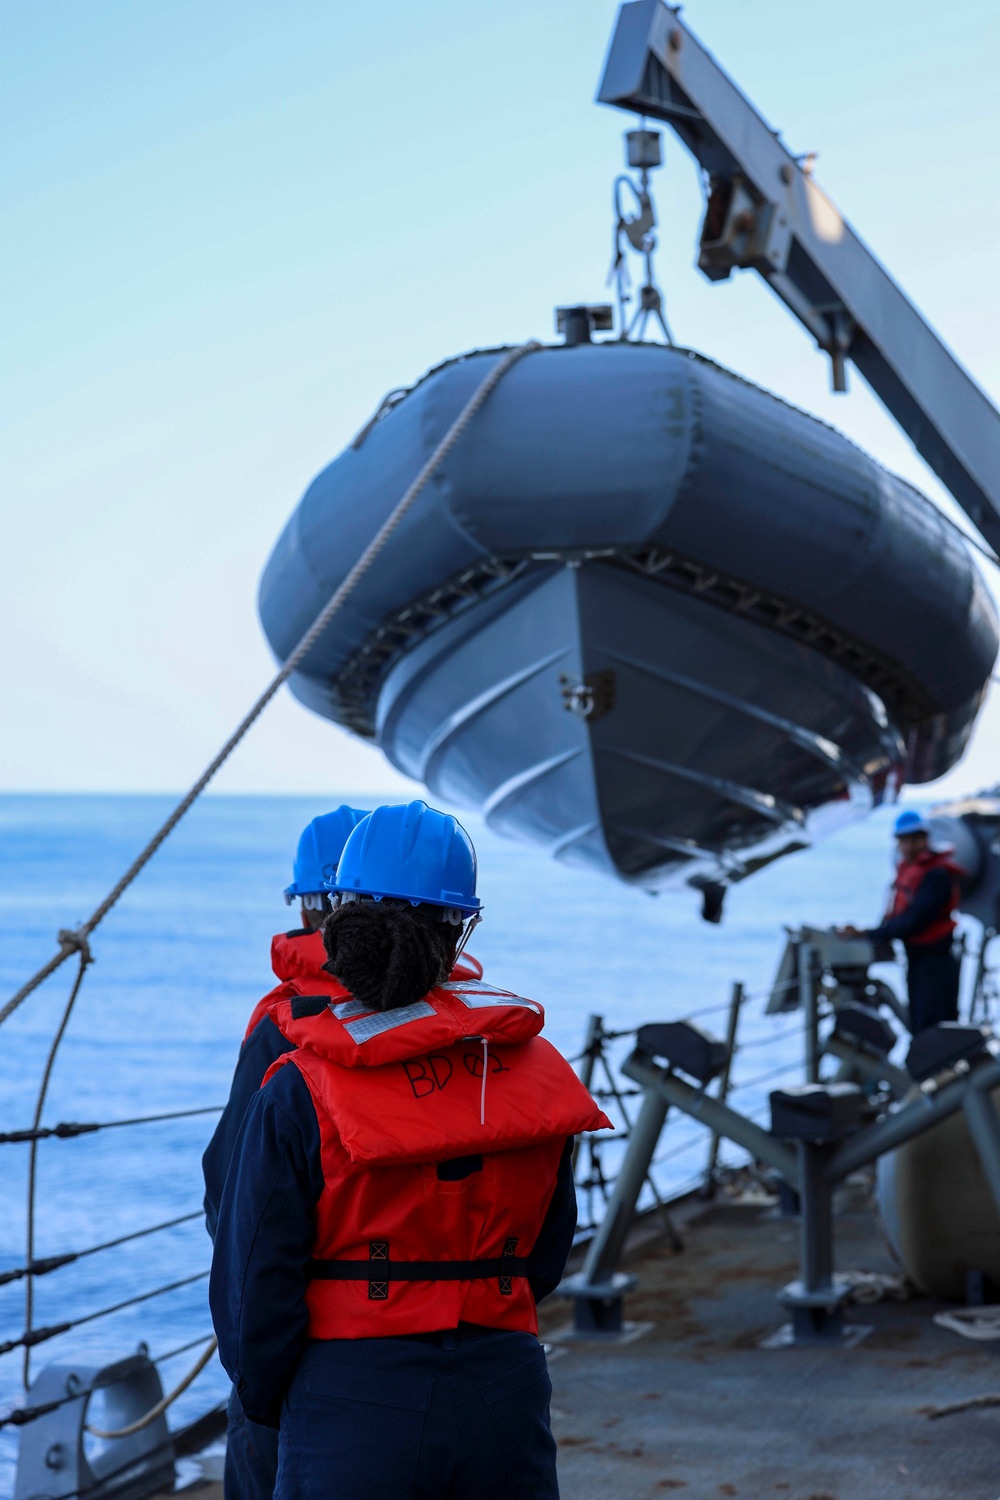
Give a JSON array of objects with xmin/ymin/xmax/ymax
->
[{"xmin": 265, "ymin": 980, "xmax": 610, "ymax": 1338}]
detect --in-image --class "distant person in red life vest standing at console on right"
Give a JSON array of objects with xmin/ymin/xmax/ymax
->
[{"xmin": 838, "ymin": 810, "xmax": 961, "ymax": 1035}]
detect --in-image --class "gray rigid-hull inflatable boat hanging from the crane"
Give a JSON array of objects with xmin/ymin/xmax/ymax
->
[{"xmin": 259, "ymin": 342, "xmax": 997, "ymax": 888}]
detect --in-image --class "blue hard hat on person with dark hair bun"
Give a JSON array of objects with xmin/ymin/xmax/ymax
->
[{"xmin": 328, "ymin": 803, "xmax": 483, "ymax": 917}]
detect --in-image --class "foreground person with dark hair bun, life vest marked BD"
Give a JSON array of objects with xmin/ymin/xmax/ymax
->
[{"xmin": 210, "ymin": 803, "xmax": 607, "ymax": 1500}]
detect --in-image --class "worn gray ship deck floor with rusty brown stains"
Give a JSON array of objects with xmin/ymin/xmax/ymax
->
[{"xmin": 543, "ymin": 1187, "xmax": 1000, "ymax": 1500}]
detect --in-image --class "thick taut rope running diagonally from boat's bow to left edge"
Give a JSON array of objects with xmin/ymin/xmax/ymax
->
[{"xmin": 0, "ymin": 339, "xmax": 541, "ymax": 1026}]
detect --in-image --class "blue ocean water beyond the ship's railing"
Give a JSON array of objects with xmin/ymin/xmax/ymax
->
[{"xmin": 0, "ymin": 794, "xmax": 947, "ymax": 1496}]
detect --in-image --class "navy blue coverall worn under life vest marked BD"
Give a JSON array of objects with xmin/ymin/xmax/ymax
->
[{"xmin": 208, "ymin": 1068, "xmax": 577, "ymax": 1500}]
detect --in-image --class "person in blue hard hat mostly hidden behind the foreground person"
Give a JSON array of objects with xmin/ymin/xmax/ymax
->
[{"xmin": 202, "ymin": 804, "xmax": 483, "ymax": 1500}]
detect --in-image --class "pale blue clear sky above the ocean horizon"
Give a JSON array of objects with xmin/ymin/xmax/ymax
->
[{"xmin": 0, "ymin": 0, "xmax": 1000, "ymax": 792}]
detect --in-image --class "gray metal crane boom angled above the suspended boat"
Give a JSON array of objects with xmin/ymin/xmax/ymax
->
[{"xmin": 598, "ymin": 0, "xmax": 1000, "ymax": 551}]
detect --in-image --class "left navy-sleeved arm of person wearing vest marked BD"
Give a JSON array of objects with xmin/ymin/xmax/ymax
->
[{"xmin": 208, "ymin": 1065, "xmax": 322, "ymax": 1427}]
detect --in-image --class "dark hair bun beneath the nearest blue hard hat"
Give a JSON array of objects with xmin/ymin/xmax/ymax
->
[{"xmin": 322, "ymin": 899, "xmax": 459, "ymax": 1011}]
